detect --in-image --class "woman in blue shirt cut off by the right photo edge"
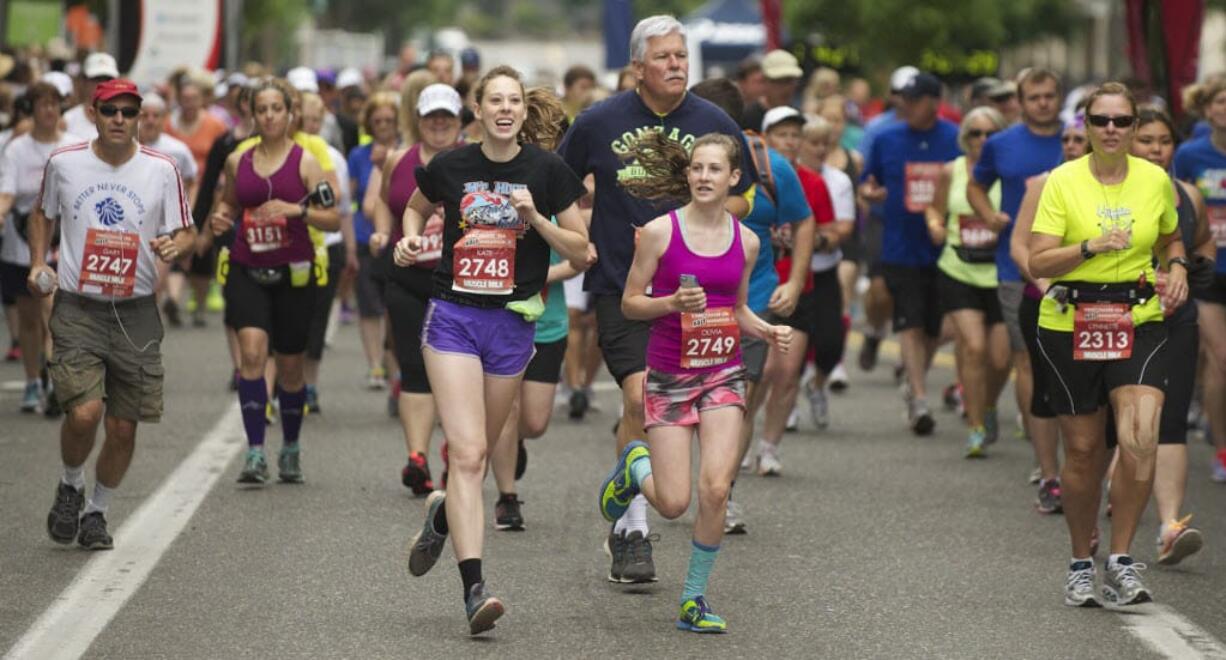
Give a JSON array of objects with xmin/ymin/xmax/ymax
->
[{"xmin": 1175, "ymin": 79, "xmax": 1226, "ymax": 483}]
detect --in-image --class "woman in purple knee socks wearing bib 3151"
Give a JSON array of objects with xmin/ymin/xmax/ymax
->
[{"xmin": 210, "ymin": 79, "xmax": 340, "ymax": 485}]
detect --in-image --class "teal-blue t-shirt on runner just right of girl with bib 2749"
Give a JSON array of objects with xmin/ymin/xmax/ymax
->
[{"xmin": 741, "ymin": 150, "xmax": 813, "ymax": 314}]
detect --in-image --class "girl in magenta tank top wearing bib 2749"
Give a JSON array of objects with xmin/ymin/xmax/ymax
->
[{"xmin": 600, "ymin": 134, "xmax": 792, "ymax": 633}]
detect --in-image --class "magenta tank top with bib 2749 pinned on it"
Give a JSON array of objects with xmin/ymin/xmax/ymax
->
[{"xmin": 647, "ymin": 211, "xmax": 745, "ymax": 374}]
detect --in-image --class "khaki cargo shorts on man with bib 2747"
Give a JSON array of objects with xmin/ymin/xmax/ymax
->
[{"xmin": 47, "ymin": 291, "xmax": 166, "ymax": 422}]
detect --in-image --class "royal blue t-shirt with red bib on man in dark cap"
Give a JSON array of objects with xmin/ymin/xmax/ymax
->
[{"xmin": 861, "ymin": 119, "xmax": 962, "ymax": 267}]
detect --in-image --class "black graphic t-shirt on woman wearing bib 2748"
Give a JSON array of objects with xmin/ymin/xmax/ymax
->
[{"xmin": 417, "ymin": 145, "xmax": 586, "ymax": 307}]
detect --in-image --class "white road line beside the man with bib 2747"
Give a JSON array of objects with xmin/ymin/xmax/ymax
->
[{"xmin": 5, "ymin": 405, "xmax": 244, "ymax": 660}]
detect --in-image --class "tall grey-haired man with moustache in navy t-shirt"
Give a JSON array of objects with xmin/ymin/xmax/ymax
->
[{"xmin": 559, "ymin": 16, "xmax": 754, "ymax": 581}]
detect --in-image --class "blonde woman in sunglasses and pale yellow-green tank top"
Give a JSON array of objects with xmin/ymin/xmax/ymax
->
[{"xmin": 924, "ymin": 106, "xmax": 1010, "ymax": 459}]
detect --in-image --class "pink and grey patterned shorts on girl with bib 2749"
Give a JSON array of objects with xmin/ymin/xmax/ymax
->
[{"xmin": 642, "ymin": 364, "xmax": 745, "ymax": 428}]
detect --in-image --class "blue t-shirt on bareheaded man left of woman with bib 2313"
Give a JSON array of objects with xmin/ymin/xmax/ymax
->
[{"xmin": 975, "ymin": 124, "xmax": 1064, "ymax": 282}]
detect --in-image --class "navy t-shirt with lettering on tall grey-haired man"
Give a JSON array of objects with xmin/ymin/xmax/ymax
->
[{"xmin": 558, "ymin": 90, "xmax": 756, "ymax": 294}]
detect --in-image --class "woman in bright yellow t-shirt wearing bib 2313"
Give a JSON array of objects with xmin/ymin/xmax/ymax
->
[{"xmin": 1029, "ymin": 82, "xmax": 1188, "ymax": 607}]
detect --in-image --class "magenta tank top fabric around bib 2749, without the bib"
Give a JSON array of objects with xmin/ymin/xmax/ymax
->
[{"xmin": 647, "ymin": 211, "xmax": 745, "ymax": 374}]
